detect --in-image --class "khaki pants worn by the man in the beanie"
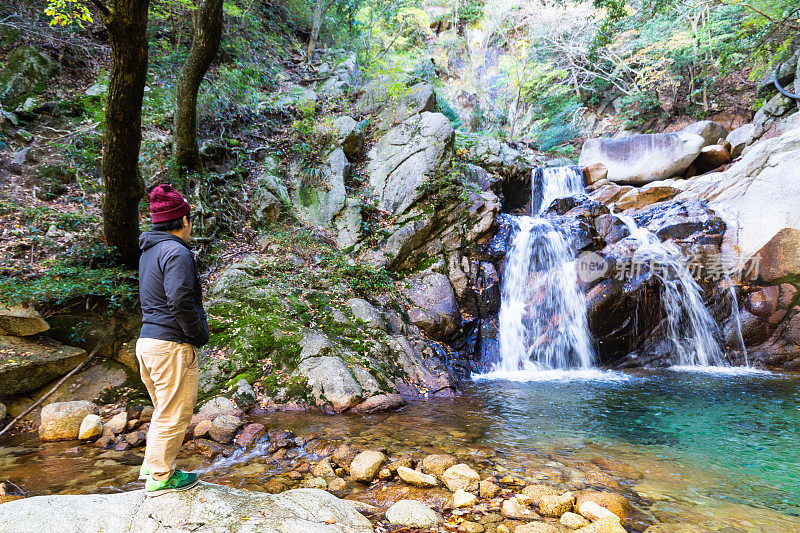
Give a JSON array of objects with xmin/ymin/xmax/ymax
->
[{"xmin": 136, "ymin": 339, "xmax": 198, "ymax": 481}]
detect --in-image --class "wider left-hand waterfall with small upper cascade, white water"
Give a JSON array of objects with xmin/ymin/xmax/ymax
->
[{"xmin": 482, "ymin": 167, "xmax": 594, "ymax": 375}]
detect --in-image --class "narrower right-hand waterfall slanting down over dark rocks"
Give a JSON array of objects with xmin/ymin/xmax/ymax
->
[{"xmin": 616, "ymin": 213, "xmax": 727, "ymax": 367}]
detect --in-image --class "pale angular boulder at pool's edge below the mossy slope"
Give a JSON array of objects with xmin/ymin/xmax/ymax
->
[{"xmin": 295, "ymin": 356, "xmax": 364, "ymax": 412}]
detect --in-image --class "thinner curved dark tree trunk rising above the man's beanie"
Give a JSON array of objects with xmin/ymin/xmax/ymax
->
[{"xmin": 175, "ymin": 0, "xmax": 222, "ymax": 175}]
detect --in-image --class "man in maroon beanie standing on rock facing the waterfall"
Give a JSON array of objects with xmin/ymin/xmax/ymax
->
[{"xmin": 136, "ymin": 185, "xmax": 208, "ymax": 496}]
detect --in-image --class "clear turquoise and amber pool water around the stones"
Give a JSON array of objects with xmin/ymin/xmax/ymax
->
[{"xmin": 0, "ymin": 367, "xmax": 800, "ymax": 533}]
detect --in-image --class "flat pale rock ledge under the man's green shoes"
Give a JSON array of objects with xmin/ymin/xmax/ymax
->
[{"xmin": 0, "ymin": 482, "xmax": 373, "ymax": 533}]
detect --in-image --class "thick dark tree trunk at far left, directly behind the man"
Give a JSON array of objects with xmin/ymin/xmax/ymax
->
[{"xmin": 101, "ymin": 0, "xmax": 150, "ymax": 266}]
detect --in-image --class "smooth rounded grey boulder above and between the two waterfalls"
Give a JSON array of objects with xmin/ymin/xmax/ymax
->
[{"xmin": 580, "ymin": 132, "xmax": 705, "ymax": 185}]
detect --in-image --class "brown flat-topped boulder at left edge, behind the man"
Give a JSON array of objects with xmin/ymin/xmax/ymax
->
[{"xmin": 0, "ymin": 336, "xmax": 86, "ymax": 396}]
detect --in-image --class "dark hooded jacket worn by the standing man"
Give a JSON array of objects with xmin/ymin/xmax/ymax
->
[{"xmin": 139, "ymin": 231, "xmax": 208, "ymax": 348}]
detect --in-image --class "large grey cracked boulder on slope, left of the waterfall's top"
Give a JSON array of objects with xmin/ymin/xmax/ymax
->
[{"xmin": 367, "ymin": 111, "xmax": 454, "ymax": 214}]
